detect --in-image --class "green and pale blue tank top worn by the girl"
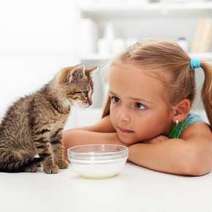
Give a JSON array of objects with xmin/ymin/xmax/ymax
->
[{"xmin": 168, "ymin": 113, "xmax": 203, "ymax": 138}]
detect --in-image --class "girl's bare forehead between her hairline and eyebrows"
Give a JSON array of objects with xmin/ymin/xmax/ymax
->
[{"xmin": 108, "ymin": 64, "xmax": 166, "ymax": 102}]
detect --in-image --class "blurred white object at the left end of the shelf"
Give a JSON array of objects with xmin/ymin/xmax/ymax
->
[{"xmin": 79, "ymin": 18, "xmax": 98, "ymax": 56}]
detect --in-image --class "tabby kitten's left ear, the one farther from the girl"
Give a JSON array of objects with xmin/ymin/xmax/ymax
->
[{"xmin": 67, "ymin": 64, "xmax": 86, "ymax": 82}]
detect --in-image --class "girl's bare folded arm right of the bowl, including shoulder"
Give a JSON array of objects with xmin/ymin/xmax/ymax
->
[{"xmin": 128, "ymin": 123, "xmax": 212, "ymax": 176}]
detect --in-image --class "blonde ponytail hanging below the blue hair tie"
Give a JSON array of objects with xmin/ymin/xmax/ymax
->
[{"xmin": 201, "ymin": 62, "xmax": 212, "ymax": 126}]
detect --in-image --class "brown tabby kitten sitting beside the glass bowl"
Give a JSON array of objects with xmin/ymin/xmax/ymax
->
[{"xmin": 0, "ymin": 66, "xmax": 96, "ymax": 174}]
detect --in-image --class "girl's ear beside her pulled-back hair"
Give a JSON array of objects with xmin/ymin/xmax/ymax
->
[{"xmin": 173, "ymin": 99, "xmax": 191, "ymax": 122}]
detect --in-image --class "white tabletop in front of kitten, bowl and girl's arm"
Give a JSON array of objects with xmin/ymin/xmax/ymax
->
[{"xmin": 0, "ymin": 164, "xmax": 212, "ymax": 212}]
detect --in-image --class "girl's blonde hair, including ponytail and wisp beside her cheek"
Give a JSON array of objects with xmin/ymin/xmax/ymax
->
[{"xmin": 102, "ymin": 41, "xmax": 212, "ymax": 125}]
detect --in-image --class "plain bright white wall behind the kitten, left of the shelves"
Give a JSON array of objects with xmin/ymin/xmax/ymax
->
[{"xmin": 0, "ymin": 0, "xmax": 79, "ymax": 118}]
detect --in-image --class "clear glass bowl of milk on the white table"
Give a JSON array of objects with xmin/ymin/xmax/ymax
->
[{"xmin": 68, "ymin": 144, "xmax": 128, "ymax": 179}]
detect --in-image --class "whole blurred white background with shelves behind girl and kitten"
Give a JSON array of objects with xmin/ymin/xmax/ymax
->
[{"xmin": 0, "ymin": 0, "xmax": 212, "ymax": 128}]
